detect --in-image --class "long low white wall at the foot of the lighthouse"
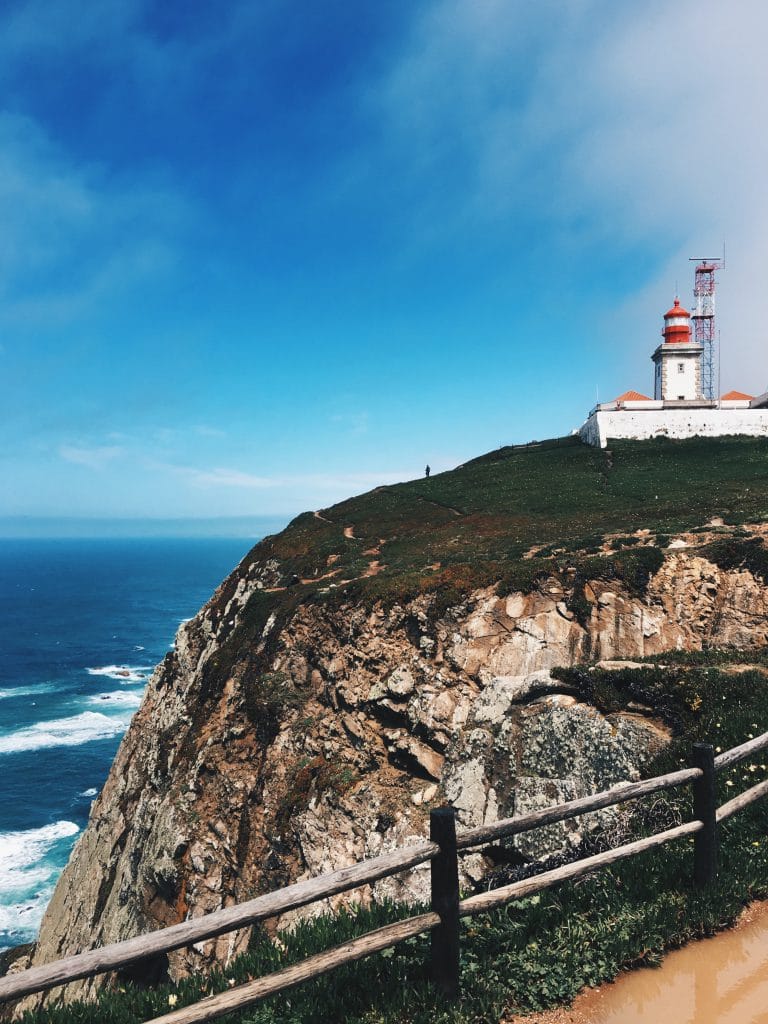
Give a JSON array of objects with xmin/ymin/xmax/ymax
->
[{"xmin": 579, "ymin": 409, "xmax": 768, "ymax": 447}]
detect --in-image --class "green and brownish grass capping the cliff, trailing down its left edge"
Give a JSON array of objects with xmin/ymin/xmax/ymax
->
[{"xmin": 199, "ymin": 437, "xmax": 768, "ymax": 696}]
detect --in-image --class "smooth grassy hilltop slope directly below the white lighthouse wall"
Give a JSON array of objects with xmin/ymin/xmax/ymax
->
[{"xmin": 254, "ymin": 437, "xmax": 768, "ymax": 601}]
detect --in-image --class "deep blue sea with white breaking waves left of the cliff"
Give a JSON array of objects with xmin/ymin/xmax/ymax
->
[{"xmin": 0, "ymin": 539, "xmax": 253, "ymax": 949}]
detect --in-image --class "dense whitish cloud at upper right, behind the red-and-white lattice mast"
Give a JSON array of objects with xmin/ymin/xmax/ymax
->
[{"xmin": 569, "ymin": 0, "xmax": 768, "ymax": 390}]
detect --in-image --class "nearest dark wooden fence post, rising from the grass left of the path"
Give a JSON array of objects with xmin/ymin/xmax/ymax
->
[{"xmin": 429, "ymin": 807, "xmax": 459, "ymax": 999}]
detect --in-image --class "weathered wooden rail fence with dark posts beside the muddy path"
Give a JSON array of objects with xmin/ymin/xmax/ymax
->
[{"xmin": 0, "ymin": 732, "xmax": 768, "ymax": 1024}]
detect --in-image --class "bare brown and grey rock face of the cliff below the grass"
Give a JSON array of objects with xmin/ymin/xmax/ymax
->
[{"xmin": 20, "ymin": 535, "xmax": 768, "ymax": 994}]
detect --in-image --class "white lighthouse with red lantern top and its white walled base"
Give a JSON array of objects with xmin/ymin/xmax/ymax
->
[{"xmin": 579, "ymin": 282, "xmax": 768, "ymax": 447}]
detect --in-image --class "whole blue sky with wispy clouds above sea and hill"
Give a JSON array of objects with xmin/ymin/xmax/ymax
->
[{"xmin": 0, "ymin": 0, "xmax": 768, "ymax": 519}]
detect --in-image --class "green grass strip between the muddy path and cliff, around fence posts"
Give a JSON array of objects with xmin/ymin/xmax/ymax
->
[{"xmin": 20, "ymin": 808, "xmax": 768, "ymax": 1024}]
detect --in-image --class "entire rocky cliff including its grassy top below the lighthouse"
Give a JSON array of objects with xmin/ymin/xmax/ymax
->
[{"xmin": 19, "ymin": 439, "xmax": 768, "ymax": 994}]
